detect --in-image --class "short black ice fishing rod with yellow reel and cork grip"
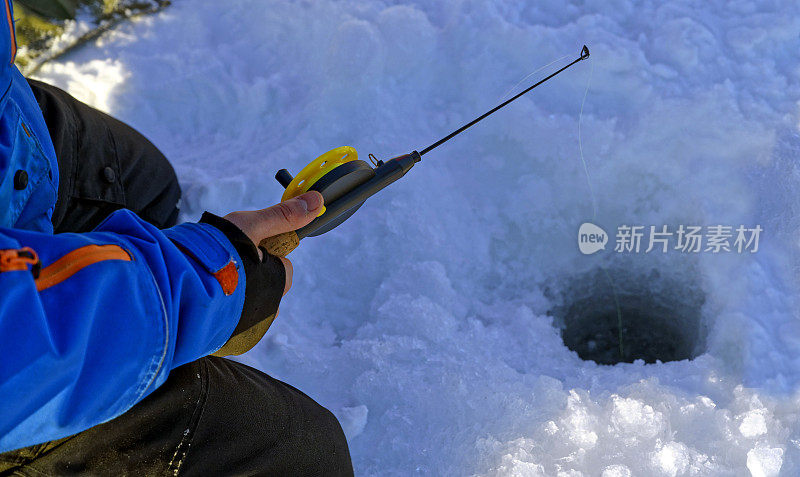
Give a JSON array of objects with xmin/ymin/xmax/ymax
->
[{"xmin": 260, "ymin": 45, "xmax": 589, "ymax": 257}]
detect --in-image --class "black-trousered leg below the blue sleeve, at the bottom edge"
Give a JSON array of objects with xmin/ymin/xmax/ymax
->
[{"xmin": 0, "ymin": 357, "xmax": 353, "ymax": 476}]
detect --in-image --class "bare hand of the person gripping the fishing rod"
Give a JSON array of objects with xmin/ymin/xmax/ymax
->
[{"xmin": 225, "ymin": 191, "xmax": 324, "ymax": 295}]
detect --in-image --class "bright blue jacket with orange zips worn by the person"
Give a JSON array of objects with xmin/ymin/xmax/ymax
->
[{"xmin": 0, "ymin": 0, "xmax": 245, "ymax": 452}]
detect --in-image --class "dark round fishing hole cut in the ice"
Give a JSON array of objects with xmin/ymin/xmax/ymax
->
[{"xmin": 551, "ymin": 269, "xmax": 706, "ymax": 365}]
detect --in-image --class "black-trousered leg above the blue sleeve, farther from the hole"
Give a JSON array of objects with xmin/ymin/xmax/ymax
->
[{"xmin": 28, "ymin": 80, "xmax": 181, "ymax": 233}]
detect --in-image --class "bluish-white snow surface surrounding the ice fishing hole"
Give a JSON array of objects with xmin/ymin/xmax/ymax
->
[{"xmin": 34, "ymin": 0, "xmax": 800, "ymax": 477}]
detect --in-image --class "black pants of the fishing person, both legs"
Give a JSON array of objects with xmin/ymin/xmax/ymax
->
[{"xmin": 0, "ymin": 81, "xmax": 353, "ymax": 476}]
